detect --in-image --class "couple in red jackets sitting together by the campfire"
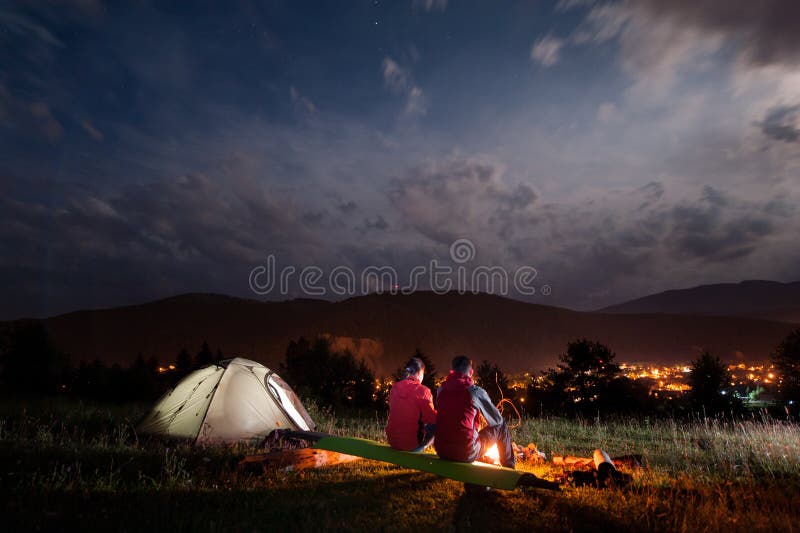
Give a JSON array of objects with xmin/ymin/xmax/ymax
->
[{"xmin": 386, "ymin": 355, "xmax": 516, "ymax": 468}]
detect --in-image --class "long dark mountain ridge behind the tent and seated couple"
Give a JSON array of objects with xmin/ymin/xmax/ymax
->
[{"xmin": 5, "ymin": 292, "xmax": 792, "ymax": 375}]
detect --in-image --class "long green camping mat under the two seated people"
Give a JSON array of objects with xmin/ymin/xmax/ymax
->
[{"xmin": 310, "ymin": 432, "xmax": 558, "ymax": 490}]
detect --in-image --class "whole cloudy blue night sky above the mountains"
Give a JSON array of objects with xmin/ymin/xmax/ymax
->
[{"xmin": 0, "ymin": 0, "xmax": 800, "ymax": 319}]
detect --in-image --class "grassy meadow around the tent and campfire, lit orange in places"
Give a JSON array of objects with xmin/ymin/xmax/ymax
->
[{"xmin": 0, "ymin": 401, "xmax": 800, "ymax": 531}]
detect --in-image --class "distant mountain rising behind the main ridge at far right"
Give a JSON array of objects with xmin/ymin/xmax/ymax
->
[{"xmin": 600, "ymin": 280, "xmax": 800, "ymax": 323}]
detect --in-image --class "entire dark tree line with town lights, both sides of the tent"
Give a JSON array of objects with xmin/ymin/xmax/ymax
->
[{"xmin": 0, "ymin": 322, "xmax": 800, "ymax": 417}]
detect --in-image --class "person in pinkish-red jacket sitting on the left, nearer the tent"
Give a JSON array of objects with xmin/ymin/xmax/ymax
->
[{"xmin": 386, "ymin": 357, "xmax": 436, "ymax": 451}]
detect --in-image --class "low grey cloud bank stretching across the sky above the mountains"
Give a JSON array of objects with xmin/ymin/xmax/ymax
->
[{"xmin": 0, "ymin": 141, "xmax": 798, "ymax": 309}]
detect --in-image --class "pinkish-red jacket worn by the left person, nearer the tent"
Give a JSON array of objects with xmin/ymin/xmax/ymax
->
[{"xmin": 386, "ymin": 378, "xmax": 436, "ymax": 450}]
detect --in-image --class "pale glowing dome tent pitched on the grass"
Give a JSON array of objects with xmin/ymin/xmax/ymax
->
[{"xmin": 138, "ymin": 357, "xmax": 314, "ymax": 444}]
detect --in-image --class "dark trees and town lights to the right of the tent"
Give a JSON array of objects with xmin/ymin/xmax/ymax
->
[{"xmin": 281, "ymin": 329, "xmax": 800, "ymax": 417}]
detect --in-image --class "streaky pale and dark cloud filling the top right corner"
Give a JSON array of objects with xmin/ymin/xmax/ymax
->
[{"xmin": 564, "ymin": 0, "xmax": 800, "ymax": 101}]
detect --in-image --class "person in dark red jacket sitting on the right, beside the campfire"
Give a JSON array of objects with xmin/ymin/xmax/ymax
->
[{"xmin": 434, "ymin": 355, "xmax": 517, "ymax": 468}]
